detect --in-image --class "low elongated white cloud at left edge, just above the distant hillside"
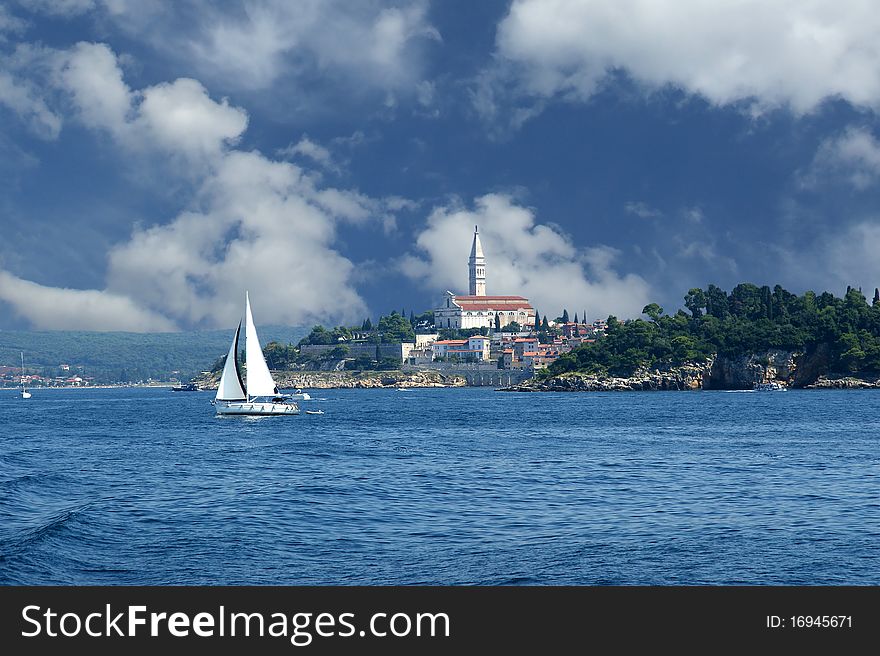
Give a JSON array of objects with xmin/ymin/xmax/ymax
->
[{"xmin": 0, "ymin": 269, "xmax": 176, "ymax": 332}]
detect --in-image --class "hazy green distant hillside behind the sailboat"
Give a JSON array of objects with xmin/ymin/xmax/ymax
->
[{"xmin": 0, "ymin": 326, "xmax": 309, "ymax": 383}]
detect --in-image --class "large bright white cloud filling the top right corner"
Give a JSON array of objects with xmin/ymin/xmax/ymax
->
[{"xmin": 492, "ymin": 0, "xmax": 880, "ymax": 113}]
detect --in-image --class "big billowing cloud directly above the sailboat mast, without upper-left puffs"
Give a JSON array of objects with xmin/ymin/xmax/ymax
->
[{"xmin": 108, "ymin": 152, "xmax": 370, "ymax": 326}]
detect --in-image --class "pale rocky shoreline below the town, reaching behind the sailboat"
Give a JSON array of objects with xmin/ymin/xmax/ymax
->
[{"xmin": 193, "ymin": 371, "xmax": 467, "ymax": 389}]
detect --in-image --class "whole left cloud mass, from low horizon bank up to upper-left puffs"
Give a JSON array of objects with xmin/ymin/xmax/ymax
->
[{"xmin": 0, "ymin": 43, "xmax": 400, "ymax": 331}]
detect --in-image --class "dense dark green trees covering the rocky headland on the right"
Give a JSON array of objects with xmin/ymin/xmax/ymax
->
[{"xmin": 544, "ymin": 283, "xmax": 880, "ymax": 376}]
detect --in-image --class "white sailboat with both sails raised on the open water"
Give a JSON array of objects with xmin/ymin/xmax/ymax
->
[{"xmin": 212, "ymin": 292, "xmax": 299, "ymax": 415}]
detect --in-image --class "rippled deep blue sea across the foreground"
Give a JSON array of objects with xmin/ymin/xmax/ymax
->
[{"xmin": 0, "ymin": 388, "xmax": 880, "ymax": 585}]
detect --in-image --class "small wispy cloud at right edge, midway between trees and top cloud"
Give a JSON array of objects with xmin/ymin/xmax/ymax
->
[{"xmin": 800, "ymin": 127, "xmax": 880, "ymax": 190}]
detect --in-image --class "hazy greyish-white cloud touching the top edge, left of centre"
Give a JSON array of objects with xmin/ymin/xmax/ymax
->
[{"xmin": 191, "ymin": 0, "xmax": 439, "ymax": 89}]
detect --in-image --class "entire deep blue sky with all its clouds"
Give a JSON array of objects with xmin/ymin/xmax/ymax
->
[{"xmin": 0, "ymin": 0, "xmax": 880, "ymax": 332}]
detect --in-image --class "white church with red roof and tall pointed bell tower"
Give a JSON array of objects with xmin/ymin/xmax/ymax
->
[{"xmin": 434, "ymin": 226, "xmax": 535, "ymax": 330}]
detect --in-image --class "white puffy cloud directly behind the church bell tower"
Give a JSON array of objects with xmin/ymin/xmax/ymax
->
[{"xmin": 400, "ymin": 194, "xmax": 649, "ymax": 317}]
